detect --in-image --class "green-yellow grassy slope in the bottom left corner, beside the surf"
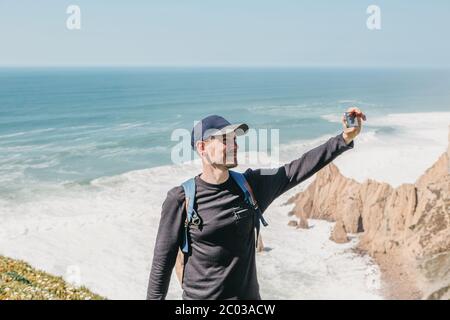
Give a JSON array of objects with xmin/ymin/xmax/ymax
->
[{"xmin": 0, "ymin": 256, "xmax": 105, "ymax": 300}]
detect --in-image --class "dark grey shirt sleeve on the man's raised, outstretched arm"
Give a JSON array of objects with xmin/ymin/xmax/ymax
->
[{"xmin": 244, "ymin": 133, "xmax": 354, "ymax": 212}]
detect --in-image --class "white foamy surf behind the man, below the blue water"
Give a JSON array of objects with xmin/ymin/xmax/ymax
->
[{"xmin": 0, "ymin": 112, "xmax": 450, "ymax": 299}]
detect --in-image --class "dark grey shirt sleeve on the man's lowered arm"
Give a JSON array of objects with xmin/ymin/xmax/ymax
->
[{"xmin": 147, "ymin": 187, "xmax": 186, "ymax": 300}]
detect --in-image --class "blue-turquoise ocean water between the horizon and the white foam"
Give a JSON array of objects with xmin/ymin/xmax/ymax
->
[{"xmin": 0, "ymin": 68, "xmax": 450, "ymax": 197}]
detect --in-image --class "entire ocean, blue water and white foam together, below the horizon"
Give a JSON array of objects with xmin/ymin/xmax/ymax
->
[{"xmin": 0, "ymin": 68, "xmax": 450, "ymax": 299}]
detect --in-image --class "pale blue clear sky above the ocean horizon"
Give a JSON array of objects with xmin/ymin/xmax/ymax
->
[{"xmin": 0, "ymin": 0, "xmax": 450, "ymax": 67}]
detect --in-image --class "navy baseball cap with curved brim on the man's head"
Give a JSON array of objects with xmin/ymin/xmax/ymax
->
[{"xmin": 191, "ymin": 115, "xmax": 248, "ymax": 149}]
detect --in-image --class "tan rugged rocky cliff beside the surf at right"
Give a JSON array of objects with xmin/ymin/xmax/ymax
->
[{"xmin": 289, "ymin": 126, "xmax": 450, "ymax": 299}]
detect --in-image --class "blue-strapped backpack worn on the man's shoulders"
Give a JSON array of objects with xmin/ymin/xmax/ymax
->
[{"xmin": 175, "ymin": 170, "xmax": 268, "ymax": 285}]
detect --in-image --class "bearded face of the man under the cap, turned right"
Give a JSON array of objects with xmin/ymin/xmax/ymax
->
[{"xmin": 202, "ymin": 132, "xmax": 238, "ymax": 168}]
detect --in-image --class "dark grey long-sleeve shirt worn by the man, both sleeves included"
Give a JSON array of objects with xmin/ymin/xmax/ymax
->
[{"xmin": 147, "ymin": 133, "xmax": 354, "ymax": 300}]
